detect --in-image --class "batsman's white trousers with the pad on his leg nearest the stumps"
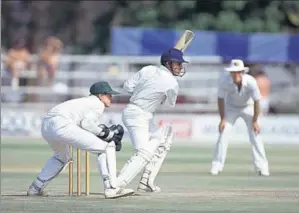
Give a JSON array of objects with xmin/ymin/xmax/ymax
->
[{"xmin": 117, "ymin": 104, "xmax": 161, "ymax": 187}]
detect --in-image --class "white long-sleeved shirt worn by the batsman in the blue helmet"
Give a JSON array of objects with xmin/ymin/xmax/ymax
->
[{"xmin": 123, "ymin": 65, "xmax": 179, "ymax": 113}]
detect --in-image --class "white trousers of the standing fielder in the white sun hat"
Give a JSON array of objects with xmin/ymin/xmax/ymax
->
[{"xmin": 212, "ymin": 106, "xmax": 269, "ymax": 171}]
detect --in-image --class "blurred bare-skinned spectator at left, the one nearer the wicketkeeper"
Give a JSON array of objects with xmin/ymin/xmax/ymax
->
[{"xmin": 37, "ymin": 36, "xmax": 63, "ymax": 86}]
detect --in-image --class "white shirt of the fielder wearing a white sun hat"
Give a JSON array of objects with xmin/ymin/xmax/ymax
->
[{"xmin": 218, "ymin": 74, "xmax": 261, "ymax": 108}]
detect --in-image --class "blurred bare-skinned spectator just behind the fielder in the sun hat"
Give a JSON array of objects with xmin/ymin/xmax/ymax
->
[{"xmin": 250, "ymin": 66, "xmax": 271, "ymax": 115}]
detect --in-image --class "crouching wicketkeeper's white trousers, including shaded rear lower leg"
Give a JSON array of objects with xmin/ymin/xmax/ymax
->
[{"xmin": 38, "ymin": 116, "xmax": 108, "ymax": 182}]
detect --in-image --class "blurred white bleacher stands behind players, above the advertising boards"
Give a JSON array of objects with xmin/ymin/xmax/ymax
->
[{"xmin": 1, "ymin": 55, "xmax": 299, "ymax": 112}]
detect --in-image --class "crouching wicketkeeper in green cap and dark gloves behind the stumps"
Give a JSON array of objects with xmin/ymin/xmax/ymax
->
[{"xmin": 27, "ymin": 82, "xmax": 134, "ymax": 198}]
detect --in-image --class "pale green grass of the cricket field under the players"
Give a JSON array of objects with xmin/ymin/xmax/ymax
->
[{"xmin": 1, "ymin": 139, "xmax": 299, "ymax": 213}]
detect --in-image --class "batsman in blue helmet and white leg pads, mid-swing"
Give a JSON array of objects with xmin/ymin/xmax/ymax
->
[{"xmin": 117, "ymin": 48, "xmax": 186, "ymax": 192}]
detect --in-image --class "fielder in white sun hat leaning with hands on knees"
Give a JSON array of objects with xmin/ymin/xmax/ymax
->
[{"xmin": 210, "ymin": 60, "xmax": 270, "ymax": 176}]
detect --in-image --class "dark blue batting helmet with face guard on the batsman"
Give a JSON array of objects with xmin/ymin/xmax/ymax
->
[{"xmin": 160, "ymin": 48, "xmax": 188, "ymax": 77}]
